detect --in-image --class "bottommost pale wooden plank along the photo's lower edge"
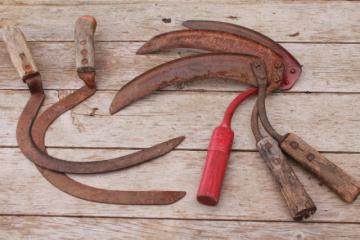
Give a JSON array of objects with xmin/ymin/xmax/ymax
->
[{"xmin": 0, "ymin": 217, "xmax": 360, "ymax": 240}]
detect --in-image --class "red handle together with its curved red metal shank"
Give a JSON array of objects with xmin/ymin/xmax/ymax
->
[{"xmin": 197, "ymin": 88, "xmax": 257, "ymax": 206}]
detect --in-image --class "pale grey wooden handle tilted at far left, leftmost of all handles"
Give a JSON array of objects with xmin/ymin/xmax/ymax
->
[{"xmin": 3, "ymin": 26, "xmax": 38, "ymax": 80}]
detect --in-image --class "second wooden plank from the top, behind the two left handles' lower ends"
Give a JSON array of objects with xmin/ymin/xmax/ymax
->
[{"xmin": 0, "ymin": 42, "xmax": 360, "ymax": 92}]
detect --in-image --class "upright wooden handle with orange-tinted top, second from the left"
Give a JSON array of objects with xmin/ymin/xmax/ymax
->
[{"xmin": 75, "ymin": 16, "xmax": 96, "ymax": 72}]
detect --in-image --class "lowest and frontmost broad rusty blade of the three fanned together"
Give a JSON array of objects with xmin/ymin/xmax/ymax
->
[{"xmin": 110, "ymin": 53, "xmax": 257, "ymax": 114}]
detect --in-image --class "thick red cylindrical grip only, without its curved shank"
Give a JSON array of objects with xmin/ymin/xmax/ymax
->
[{"xmin": 197, "ymin": 126, "xmax": 234, "ymax": 206}]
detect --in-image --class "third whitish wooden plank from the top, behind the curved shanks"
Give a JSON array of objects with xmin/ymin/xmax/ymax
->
[{"xmin": 0, "ymin": 90, "xmax": 360, "ymax": 153}]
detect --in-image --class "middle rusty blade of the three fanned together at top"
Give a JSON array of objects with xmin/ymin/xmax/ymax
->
[{"xmin": 137, "ymin": 30, "xmax": 285, "ymax": 87}]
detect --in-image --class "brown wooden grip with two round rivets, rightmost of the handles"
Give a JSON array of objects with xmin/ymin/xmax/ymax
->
[{"xmin": 280, "ymin": 133, "xmax": 360, "ymax": 203}]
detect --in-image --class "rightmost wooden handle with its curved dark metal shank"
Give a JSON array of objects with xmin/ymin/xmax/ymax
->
[{"xmin": 254, "ymin": 59, "xmax": 360, "ymax": 203}]
